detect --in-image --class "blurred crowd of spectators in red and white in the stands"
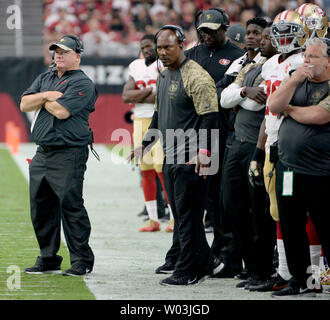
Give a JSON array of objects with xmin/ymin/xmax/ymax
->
[{"xmin": 43, "ymin": 0, "xmax": 326, "ymax": 57}]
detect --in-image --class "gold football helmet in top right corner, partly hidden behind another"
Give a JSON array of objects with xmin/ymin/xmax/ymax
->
[{"xmin": 295, "ymin": 3, "xmax": 328, "ymax": 38}]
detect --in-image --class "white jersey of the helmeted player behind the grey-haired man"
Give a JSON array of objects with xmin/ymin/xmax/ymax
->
[{"xmin": 261, "ymin": 53, "xmax": 304, "ymax": 153}]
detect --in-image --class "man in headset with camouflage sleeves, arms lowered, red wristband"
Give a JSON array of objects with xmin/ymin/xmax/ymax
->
[{"xmin": 128, "ymin": 25, "xmax": 220, "ymax": 286}]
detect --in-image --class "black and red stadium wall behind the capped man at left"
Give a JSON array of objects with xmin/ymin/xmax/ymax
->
[{"xmin": 0, "ymin": 57, "xmax": 134, "ymax": 144}]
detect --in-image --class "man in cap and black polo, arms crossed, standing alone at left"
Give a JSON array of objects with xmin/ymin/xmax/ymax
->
[{"xmin": 20, "ymin": 35, "xmax": 97, "ymax": 276}]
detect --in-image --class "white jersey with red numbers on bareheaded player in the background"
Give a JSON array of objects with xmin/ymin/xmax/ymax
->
[{"xmin": 128, "ymin": 59, "xmax": 162, "ymax": 118}]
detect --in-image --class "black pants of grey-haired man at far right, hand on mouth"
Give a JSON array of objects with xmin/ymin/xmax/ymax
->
[{"xmin": 276, "ymin": 161, "xmax": 330, "ymax": 287}]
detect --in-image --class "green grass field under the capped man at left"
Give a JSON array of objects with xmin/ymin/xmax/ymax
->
[{"xmin": 0, "ymin": 148, "xmax": 95, "ymax": 300}]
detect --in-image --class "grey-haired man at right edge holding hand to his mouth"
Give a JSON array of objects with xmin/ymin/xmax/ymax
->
[{"xmin": 269, "ymin": 38, "xmax": 330, "ymax": 297}]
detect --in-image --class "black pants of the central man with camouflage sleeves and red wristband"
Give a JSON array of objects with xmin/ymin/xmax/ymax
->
[{"xmin": 163, "ymin": 163, "xmax": 213, "ymax": 276}]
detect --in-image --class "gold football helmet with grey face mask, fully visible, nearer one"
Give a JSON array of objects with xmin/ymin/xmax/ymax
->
[{"xmin": 270, "ymin": 10, "xmax": 308, "ymax": 53}]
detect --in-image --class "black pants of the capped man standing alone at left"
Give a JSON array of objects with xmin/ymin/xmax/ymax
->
[{"xmin": 29, "ymin": 146, "xmax": 94, "ymax": 268}]
